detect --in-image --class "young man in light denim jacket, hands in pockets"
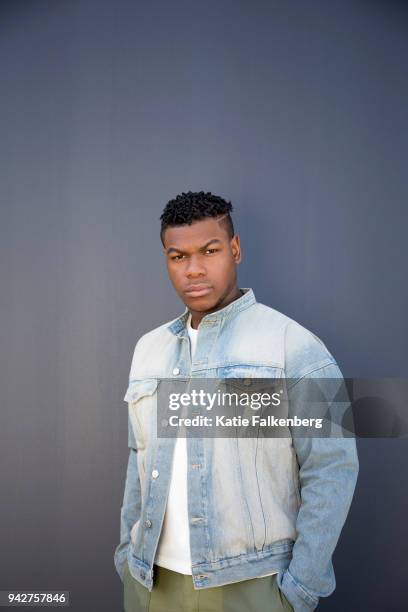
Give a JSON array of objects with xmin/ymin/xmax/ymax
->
[{"xmin": 115, "ymin": 191, "xmax": 358, "ymax": 612}]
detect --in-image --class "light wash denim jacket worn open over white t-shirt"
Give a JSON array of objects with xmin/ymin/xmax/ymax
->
[{"xmin": 114, "ymin": 288, "xmax": 359, "ymax": 612}]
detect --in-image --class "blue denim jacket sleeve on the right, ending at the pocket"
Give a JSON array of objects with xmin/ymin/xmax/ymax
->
[{"xmin": 277, "ymin": 358, "xmax": 359, "ymax": 612}]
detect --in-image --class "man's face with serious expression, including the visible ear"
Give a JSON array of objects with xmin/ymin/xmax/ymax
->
[{"xmin": 163, "ymin": 217, "xmax": 241, "ymax": 325}]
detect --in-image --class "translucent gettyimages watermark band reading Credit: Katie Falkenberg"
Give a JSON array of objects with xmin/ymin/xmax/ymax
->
[{"xmin": 139, "ymin": 377, "xmax": 408, "ymax": 438}]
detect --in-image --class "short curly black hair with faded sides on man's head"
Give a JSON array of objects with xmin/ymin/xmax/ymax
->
[{"xmin": 160, "ymin": 191, "xmax": 235, "ymax": 246}]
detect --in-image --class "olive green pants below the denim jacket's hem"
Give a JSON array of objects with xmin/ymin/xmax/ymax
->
[{"xmin": 123, "ymin": 564, "xmax": 293, "ymax": 612}]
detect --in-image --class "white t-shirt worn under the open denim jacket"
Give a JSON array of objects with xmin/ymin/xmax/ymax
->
[{"xmin": 154, "ymin": 313, "xmax": 277, "ymax": 578}]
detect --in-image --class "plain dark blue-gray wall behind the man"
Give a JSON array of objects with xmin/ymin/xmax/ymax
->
[{"xmin": 0, "ymin": 0, "xmax": 408, "ymax": 612}]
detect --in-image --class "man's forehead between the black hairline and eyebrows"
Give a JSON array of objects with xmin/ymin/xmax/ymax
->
[{"xmin": 163, "ymin": 217, "xmax": 229, "ymax": 249}]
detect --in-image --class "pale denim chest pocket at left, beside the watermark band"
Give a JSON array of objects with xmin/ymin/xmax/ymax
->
[{"xmin": 124, "ymin": 378, "xmax": 158, "ymax": 452}]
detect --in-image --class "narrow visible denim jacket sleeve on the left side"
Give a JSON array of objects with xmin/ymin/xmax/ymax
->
[{"xmin": 114, "ymin": 408, "xmax": 141, "ymax": 581}]
